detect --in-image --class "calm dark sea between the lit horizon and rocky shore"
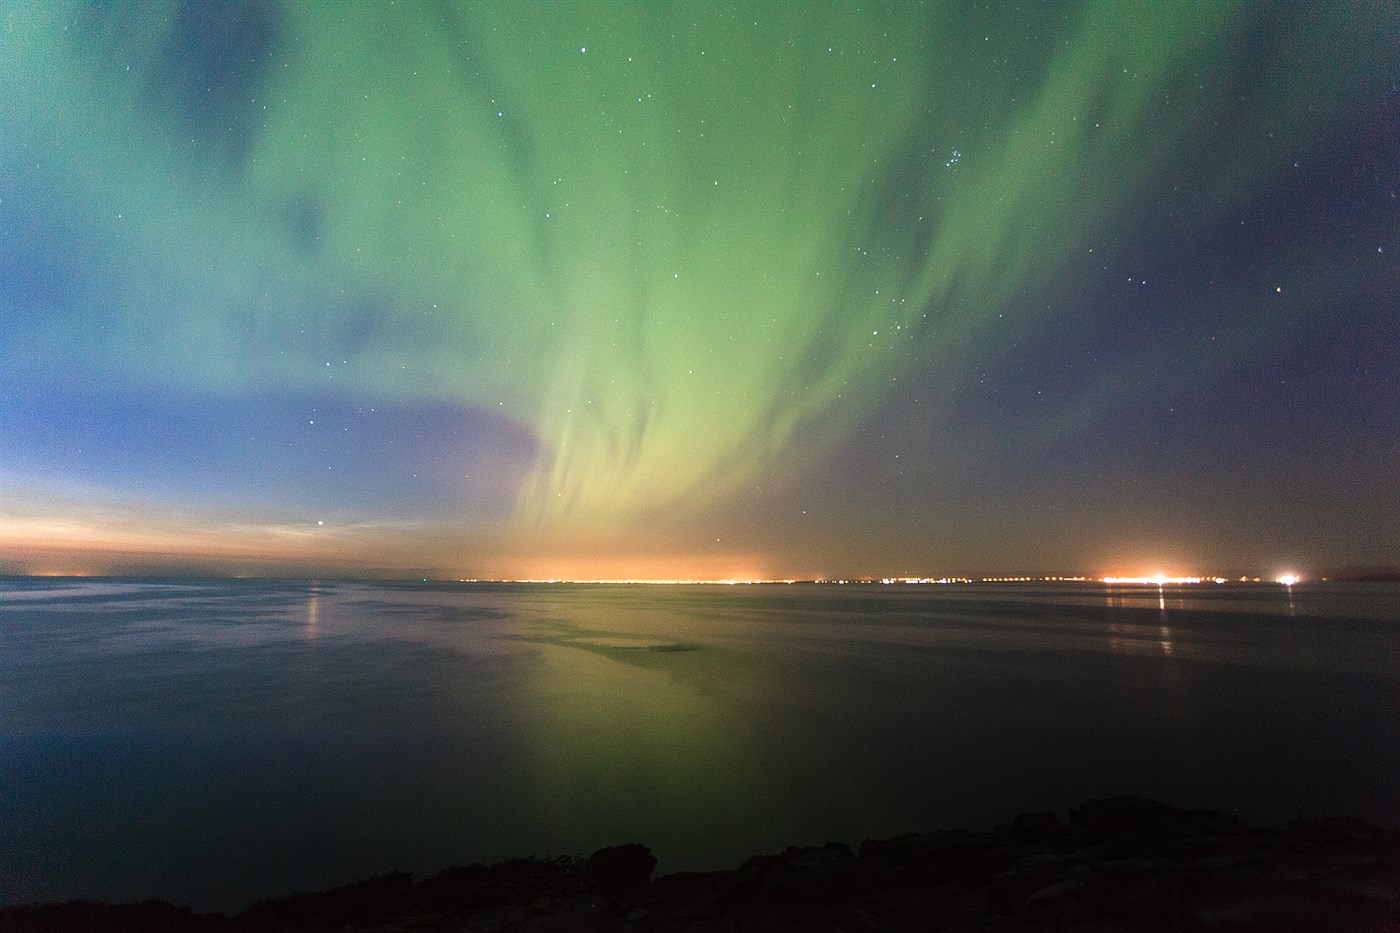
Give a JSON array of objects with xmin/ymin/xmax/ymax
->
[{"xmin": 0, "ymin": 579, "xmax": 1400, "ymax": 909}]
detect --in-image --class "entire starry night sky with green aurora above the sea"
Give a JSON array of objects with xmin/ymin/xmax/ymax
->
[{"xmin": 0, "ymin": 0, "xmax": 1400, "ymax": 579}]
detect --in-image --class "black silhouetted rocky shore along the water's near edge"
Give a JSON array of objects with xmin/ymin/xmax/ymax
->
[{"xmin": 0, "ymin": 797, "xmax": 1400, "ymax": 933}]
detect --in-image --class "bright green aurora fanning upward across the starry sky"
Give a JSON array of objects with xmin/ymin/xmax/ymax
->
[{"xmin": 0, "ymin": 0, "xmax": 1372, "ymax": 532}]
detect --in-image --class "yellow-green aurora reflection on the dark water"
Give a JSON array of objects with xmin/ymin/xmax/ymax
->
[{"xmin": 512, "ymin": 619, "xmax": 777, "ymax": 869}]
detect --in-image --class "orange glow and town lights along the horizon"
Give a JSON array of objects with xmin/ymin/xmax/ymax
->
[{"xmin": 0, "ymin": 506, "xmax": 1303, "ymax": 587}]
